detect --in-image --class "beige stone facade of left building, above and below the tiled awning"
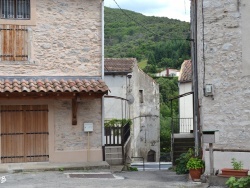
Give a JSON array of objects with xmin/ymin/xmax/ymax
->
[{"xmin": 0, "ymin": 0, "xmax": 106, "ymax": 162}]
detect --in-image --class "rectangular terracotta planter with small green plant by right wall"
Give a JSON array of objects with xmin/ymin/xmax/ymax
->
[{"xmin": 220, "ymin": 158, "xmax": 248, "ymax": 177}]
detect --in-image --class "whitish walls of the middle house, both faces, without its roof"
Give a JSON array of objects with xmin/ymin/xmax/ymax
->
[{"xmin": 105, "ymin": 66, "xmax": 160, "ymax": 160}]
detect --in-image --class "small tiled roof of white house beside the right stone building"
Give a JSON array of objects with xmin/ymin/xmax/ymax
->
[{"xmin": 179, "ymin": 60, "xmax": 193, "ymax": 82}]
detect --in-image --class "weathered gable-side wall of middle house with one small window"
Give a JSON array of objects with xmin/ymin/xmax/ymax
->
[{"xmin": 130, "ymin": 66, "xmax": 160, "ymax": 161}]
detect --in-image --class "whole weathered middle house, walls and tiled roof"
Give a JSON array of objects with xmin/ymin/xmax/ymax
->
[{"xmin": 104, "ymin": 58, "xmax": 160, "ymax": 161}]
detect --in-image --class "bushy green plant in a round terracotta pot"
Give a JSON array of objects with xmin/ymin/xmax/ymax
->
[{"xmin": 187, "ymin": 157, "xmax": 205, "ymax": 181}]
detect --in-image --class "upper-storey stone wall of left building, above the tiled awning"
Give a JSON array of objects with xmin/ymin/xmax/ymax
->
[{"xmin": 0, "ymin": 0, "xmax": 102, "ymax": 76}]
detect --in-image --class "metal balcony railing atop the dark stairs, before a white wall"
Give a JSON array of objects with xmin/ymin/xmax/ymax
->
[{"xmin": 172, "ymin": 118, "xmax": 193, "ymax": 133}]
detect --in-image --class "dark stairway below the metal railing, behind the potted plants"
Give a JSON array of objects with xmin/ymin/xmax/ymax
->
[{"xmin": 173, "ymin": 134, "xmax": 195, "ymax": 165}]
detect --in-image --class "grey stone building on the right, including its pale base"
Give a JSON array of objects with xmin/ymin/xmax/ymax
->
[{"xmin": 191, "ymin": 0, "xmax": 250, "ymax": 172}]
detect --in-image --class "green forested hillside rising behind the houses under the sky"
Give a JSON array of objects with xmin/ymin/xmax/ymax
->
[{"xmin": 105, "ymin": 7, "xmax": 190, "ymax": 70}]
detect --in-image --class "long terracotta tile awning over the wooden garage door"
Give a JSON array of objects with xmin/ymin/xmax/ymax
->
[{"xmin": 0, "ymin": 79, "xmax": 109, "ymax": 93}]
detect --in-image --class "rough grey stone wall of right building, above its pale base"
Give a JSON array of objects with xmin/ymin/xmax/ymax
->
[{"xmin": 194, "ymin": 0, "xmax": 250, "ymax": 173}]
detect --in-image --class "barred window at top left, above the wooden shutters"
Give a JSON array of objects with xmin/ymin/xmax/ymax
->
[{"xmin": 1, "ymin": 0, "xmax": 30, "ymax": 19}]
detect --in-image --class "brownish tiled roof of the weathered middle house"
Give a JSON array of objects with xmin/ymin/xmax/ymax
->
[{"xmin": 104, "ymin": 58, "xmax": 137, "ymax": 72}]
